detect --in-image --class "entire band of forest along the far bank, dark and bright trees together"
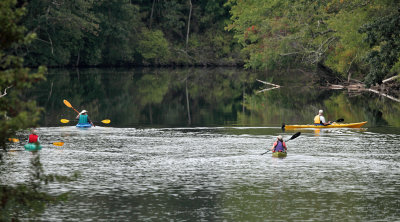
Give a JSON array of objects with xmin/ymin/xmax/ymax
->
[{"xmin": 12, "ymin": 0, "xmax": 400, "ymax": 85}]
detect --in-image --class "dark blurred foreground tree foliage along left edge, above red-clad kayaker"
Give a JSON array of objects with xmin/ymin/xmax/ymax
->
[{"xmin": 0, "ymin": 0, "xmax": 46, "ymax": 150}]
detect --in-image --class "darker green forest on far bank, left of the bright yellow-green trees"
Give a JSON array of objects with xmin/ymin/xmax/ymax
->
[{"xmin": 23, "ymin": 0, "xmax": 241, "ymax": 66}]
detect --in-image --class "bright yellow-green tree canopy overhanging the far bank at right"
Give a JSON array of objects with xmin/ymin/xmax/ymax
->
[{"xmin": 226, "ymin": 0, "xmax": 400, "ymax": 84}]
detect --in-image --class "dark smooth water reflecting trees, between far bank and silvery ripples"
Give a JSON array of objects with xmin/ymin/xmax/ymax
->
[{"xmin": 28, "ymin": 68, "xmax": 400, "ymax": 127}]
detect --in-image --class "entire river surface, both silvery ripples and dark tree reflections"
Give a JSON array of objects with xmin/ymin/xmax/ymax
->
[{"xmin": 1, "ymin": 68, "xmax": 400, "ymax": 221}]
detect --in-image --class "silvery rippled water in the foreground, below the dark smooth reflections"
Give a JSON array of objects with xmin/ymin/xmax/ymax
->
[{"xmin": 2, "ymin": 126, "xmax": 400, "ymax": 221}]
